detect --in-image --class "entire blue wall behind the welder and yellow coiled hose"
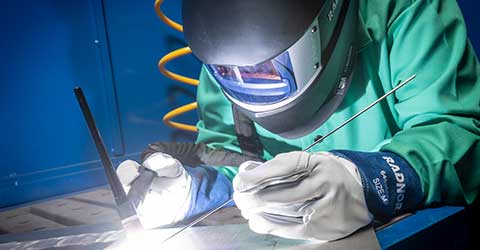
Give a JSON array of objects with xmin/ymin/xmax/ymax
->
[{"xmin": 0, "ymin": 0, "xmax": 480, "ymax": 208}]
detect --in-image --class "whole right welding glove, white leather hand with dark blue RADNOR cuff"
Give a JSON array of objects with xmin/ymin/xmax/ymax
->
[{"xmin": 233, "ymin": 151, "xmax": 422, "ymax": 241}]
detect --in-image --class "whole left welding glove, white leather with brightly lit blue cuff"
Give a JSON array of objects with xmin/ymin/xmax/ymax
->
[{"xmin": 117, "ymin": 152, "xmax": 233, "ymax": 229}]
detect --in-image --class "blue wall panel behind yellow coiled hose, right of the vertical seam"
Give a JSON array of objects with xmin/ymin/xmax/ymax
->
[{"xmin": 104, "ymin": 0, "xmax": 201, "ymax": 152}]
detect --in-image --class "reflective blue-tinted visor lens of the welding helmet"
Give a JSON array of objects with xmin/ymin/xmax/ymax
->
[{"xmin": 207, "ymin": 51, "xmax": 297, "ymax": 105}]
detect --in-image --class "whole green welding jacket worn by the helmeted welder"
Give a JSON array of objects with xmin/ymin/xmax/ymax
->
[{"xmin": 193, "ymin": 0, "xmax": 480, "ymax": 206}]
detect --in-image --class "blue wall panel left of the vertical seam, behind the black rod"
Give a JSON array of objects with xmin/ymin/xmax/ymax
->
[{"xmin": 0, "ymin": 0, "xmax": 123, "ymax": 207}]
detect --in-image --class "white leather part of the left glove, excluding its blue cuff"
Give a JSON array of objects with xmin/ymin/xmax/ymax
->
[{"xmin": 117, "ymin": 153, "xmax": 192, "ymax": 229}]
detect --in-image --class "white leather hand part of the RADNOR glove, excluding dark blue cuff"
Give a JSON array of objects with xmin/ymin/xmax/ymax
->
[{"xmin": 233, "ymin": 152, "xmax": 373, "ymax": 241}]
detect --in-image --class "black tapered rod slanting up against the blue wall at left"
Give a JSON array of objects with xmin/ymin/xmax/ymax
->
[{"xmin": 73, "ymin": 87, "xmax": 136, "ymax": 219}]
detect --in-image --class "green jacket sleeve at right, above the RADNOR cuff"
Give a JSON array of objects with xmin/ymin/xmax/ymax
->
[{"xmin": 381, "ymin": 0, "xmax": 480, "ymax": 205}]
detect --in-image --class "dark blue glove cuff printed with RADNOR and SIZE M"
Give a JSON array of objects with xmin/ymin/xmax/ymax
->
[{"xmin": 331, "ymin": 150, "xmax": 423, "ymax": 219}]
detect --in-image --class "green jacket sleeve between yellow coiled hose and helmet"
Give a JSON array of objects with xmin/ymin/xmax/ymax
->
[{"xmin": 193, "ymin": 67, "xmax": 241, "ymax": 180}]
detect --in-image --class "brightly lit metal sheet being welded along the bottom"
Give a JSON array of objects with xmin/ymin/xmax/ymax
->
[{"xmin": 0, "ymin": 224, "xmax": 380, "ymax": 250}]
